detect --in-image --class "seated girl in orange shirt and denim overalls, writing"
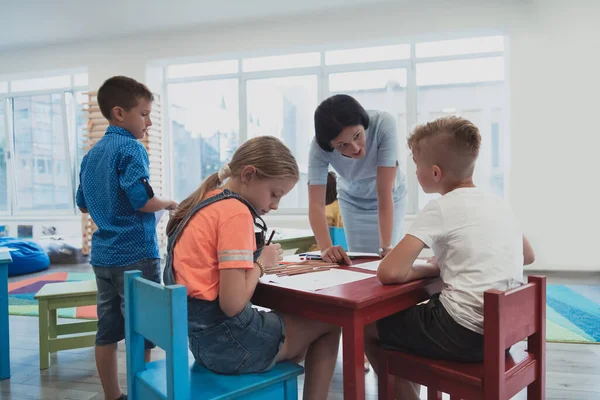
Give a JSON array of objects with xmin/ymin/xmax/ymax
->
[{"xmin": 164, "ymin": 136, "xmax": 340, "ymax": 400}]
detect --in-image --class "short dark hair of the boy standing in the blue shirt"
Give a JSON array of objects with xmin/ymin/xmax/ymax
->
[{"xmin": 98, "ymin": 76, "xmax": 154, "ymax": 121}]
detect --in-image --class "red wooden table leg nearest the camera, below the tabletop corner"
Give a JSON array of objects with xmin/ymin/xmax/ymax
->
[{"xmin": 342, "ymin": 317, "xmax": 365, "ymax": 400}]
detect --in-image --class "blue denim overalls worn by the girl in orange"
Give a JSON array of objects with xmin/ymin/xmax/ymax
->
[{"xmin": 163, "ymin": 189, "xmax": 285, "ymax": 374}]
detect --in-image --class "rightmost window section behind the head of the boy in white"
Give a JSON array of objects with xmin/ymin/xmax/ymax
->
[{"xmin": 416, "ymin": 43, "xmax": 507, "ymax": 208}]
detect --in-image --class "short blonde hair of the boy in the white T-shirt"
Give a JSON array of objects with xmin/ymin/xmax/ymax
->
[{"xmin": 408, "ymin": 116, "xmax": 481, "ymax": 179}]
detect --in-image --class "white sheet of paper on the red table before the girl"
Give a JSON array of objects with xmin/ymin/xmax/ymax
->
[{"xmin": 261, "ymin": 268, "xmax": 373, "ymax": 292}]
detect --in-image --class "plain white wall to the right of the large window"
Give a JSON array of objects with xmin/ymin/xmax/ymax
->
[{"xmin": 509, "ymin": 0, "xmax": 600, "ymax": 269}]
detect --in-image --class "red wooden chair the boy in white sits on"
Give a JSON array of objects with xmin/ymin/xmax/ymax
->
[{"xmin": 379, "ymin": 276, "xmax": 546, "ymax": 400}]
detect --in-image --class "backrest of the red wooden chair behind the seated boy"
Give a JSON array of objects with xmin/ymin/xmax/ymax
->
[{"xmin": 483, "ymin": 276, "xmax": 546, "ymax": 391}]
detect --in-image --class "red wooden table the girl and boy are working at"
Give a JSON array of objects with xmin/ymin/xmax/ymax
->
[{"xmin": 252, "ymin": 259, "xmax": 442, "ymax": 400}]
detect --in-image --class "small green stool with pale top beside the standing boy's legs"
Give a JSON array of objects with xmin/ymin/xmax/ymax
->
[{"xmin": 35, "ymin": 280, "xmax": 98, "ymax": 369}]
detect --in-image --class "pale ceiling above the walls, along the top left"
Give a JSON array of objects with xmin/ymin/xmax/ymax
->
[{"xmin": 0, "ymin": 0, "xmax": 404, "ymax": 51}]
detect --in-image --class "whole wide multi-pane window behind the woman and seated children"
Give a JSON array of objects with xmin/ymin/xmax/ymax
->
[{"xmin": 167, "ymin": 36, "xmax": 508, "ymax": 213}]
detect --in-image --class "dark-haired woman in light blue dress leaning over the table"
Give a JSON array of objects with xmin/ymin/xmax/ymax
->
[{"xmin": 308, "ymin": 94, "xmax": 406, "ymax": 264}]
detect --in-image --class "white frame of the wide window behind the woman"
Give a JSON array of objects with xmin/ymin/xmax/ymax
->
[{"xmin": 163, "ymin": 36, "xmax": 508, "ymax": 218}]
